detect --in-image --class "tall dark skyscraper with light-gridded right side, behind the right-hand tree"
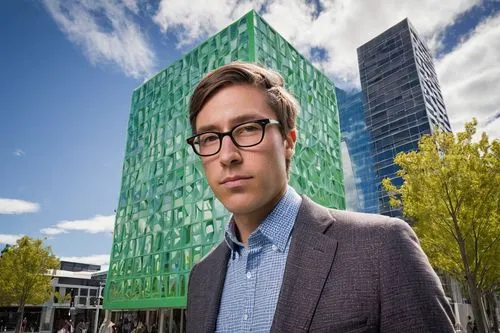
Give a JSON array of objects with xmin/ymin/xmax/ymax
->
[{"xmin": 358, "ymin": 19, "xmax": 451, "ymax": 216}]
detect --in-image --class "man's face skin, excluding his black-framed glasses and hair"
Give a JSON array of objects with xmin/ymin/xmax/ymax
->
[{"xmin": 196, "ymin": 85, "xmax": 296, "ymax": 215}]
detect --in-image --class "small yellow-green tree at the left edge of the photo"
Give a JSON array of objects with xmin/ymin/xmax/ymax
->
[{"xmin": 0, "ymin": 236, "xmax": 59, "ymax": 332}]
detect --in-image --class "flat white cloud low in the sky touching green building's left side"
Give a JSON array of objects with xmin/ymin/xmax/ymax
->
[{"xmin": 51, "ymin": 215, "xmax": 115, "ymax": 235}]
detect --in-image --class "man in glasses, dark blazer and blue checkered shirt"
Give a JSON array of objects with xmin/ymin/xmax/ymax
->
[{"xmin": 187, "ymin": 63, "xmax": 453, "ymax": 333}]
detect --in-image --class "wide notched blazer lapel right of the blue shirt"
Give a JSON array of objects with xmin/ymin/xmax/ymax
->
[{"xmin": 271, "ymin": 196, "xmax": 337, "ymax": 332}]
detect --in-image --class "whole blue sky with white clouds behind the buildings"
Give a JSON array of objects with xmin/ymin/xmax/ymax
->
[{"xmin": 0, "ymin": 0, "xmax": 500, "ymax": 264}]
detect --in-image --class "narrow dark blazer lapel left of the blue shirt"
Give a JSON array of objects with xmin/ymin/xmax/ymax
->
[{"xmin": 200, "ymin": 242, "xmax": 231, "ymax": 332}]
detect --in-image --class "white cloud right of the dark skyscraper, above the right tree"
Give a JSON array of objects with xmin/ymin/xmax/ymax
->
[{"xmin": 436, "ymin": 14, "xmax": 500, "ymax": 139}]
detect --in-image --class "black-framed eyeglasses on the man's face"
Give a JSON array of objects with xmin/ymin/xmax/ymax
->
[{"xmin": 186, "ymin": 119, "xmax": 280, "ymax": 156}]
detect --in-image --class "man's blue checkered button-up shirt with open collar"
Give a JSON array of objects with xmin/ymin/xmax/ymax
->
[{"xmin": 216, "ymin": 186, "xmax": 302, "ymax": 333}]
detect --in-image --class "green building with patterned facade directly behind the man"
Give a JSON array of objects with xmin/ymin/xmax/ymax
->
[{"xmin": 104, "ymin": 11, "xmax": 345, "ymax": 309}]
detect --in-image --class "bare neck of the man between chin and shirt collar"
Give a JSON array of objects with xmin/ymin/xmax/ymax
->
[{"xmin": 233, "ymin": 186, "xmax": 287, "ymax": 247}]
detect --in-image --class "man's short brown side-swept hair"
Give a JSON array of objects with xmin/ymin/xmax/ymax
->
[{"xmin": 189, "ymin": 62, "xmax": 299, "ymax": 136}]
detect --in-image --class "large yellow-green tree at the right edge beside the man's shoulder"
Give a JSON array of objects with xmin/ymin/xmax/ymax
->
[{"xmin": 383, "ymin": 119, "xmax": 500, "ymax": 332}]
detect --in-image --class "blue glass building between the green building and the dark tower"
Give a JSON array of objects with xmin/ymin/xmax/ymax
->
[{"xmin": 335, "ymin": 88, "xmax": 378, "ymax": 213}]
